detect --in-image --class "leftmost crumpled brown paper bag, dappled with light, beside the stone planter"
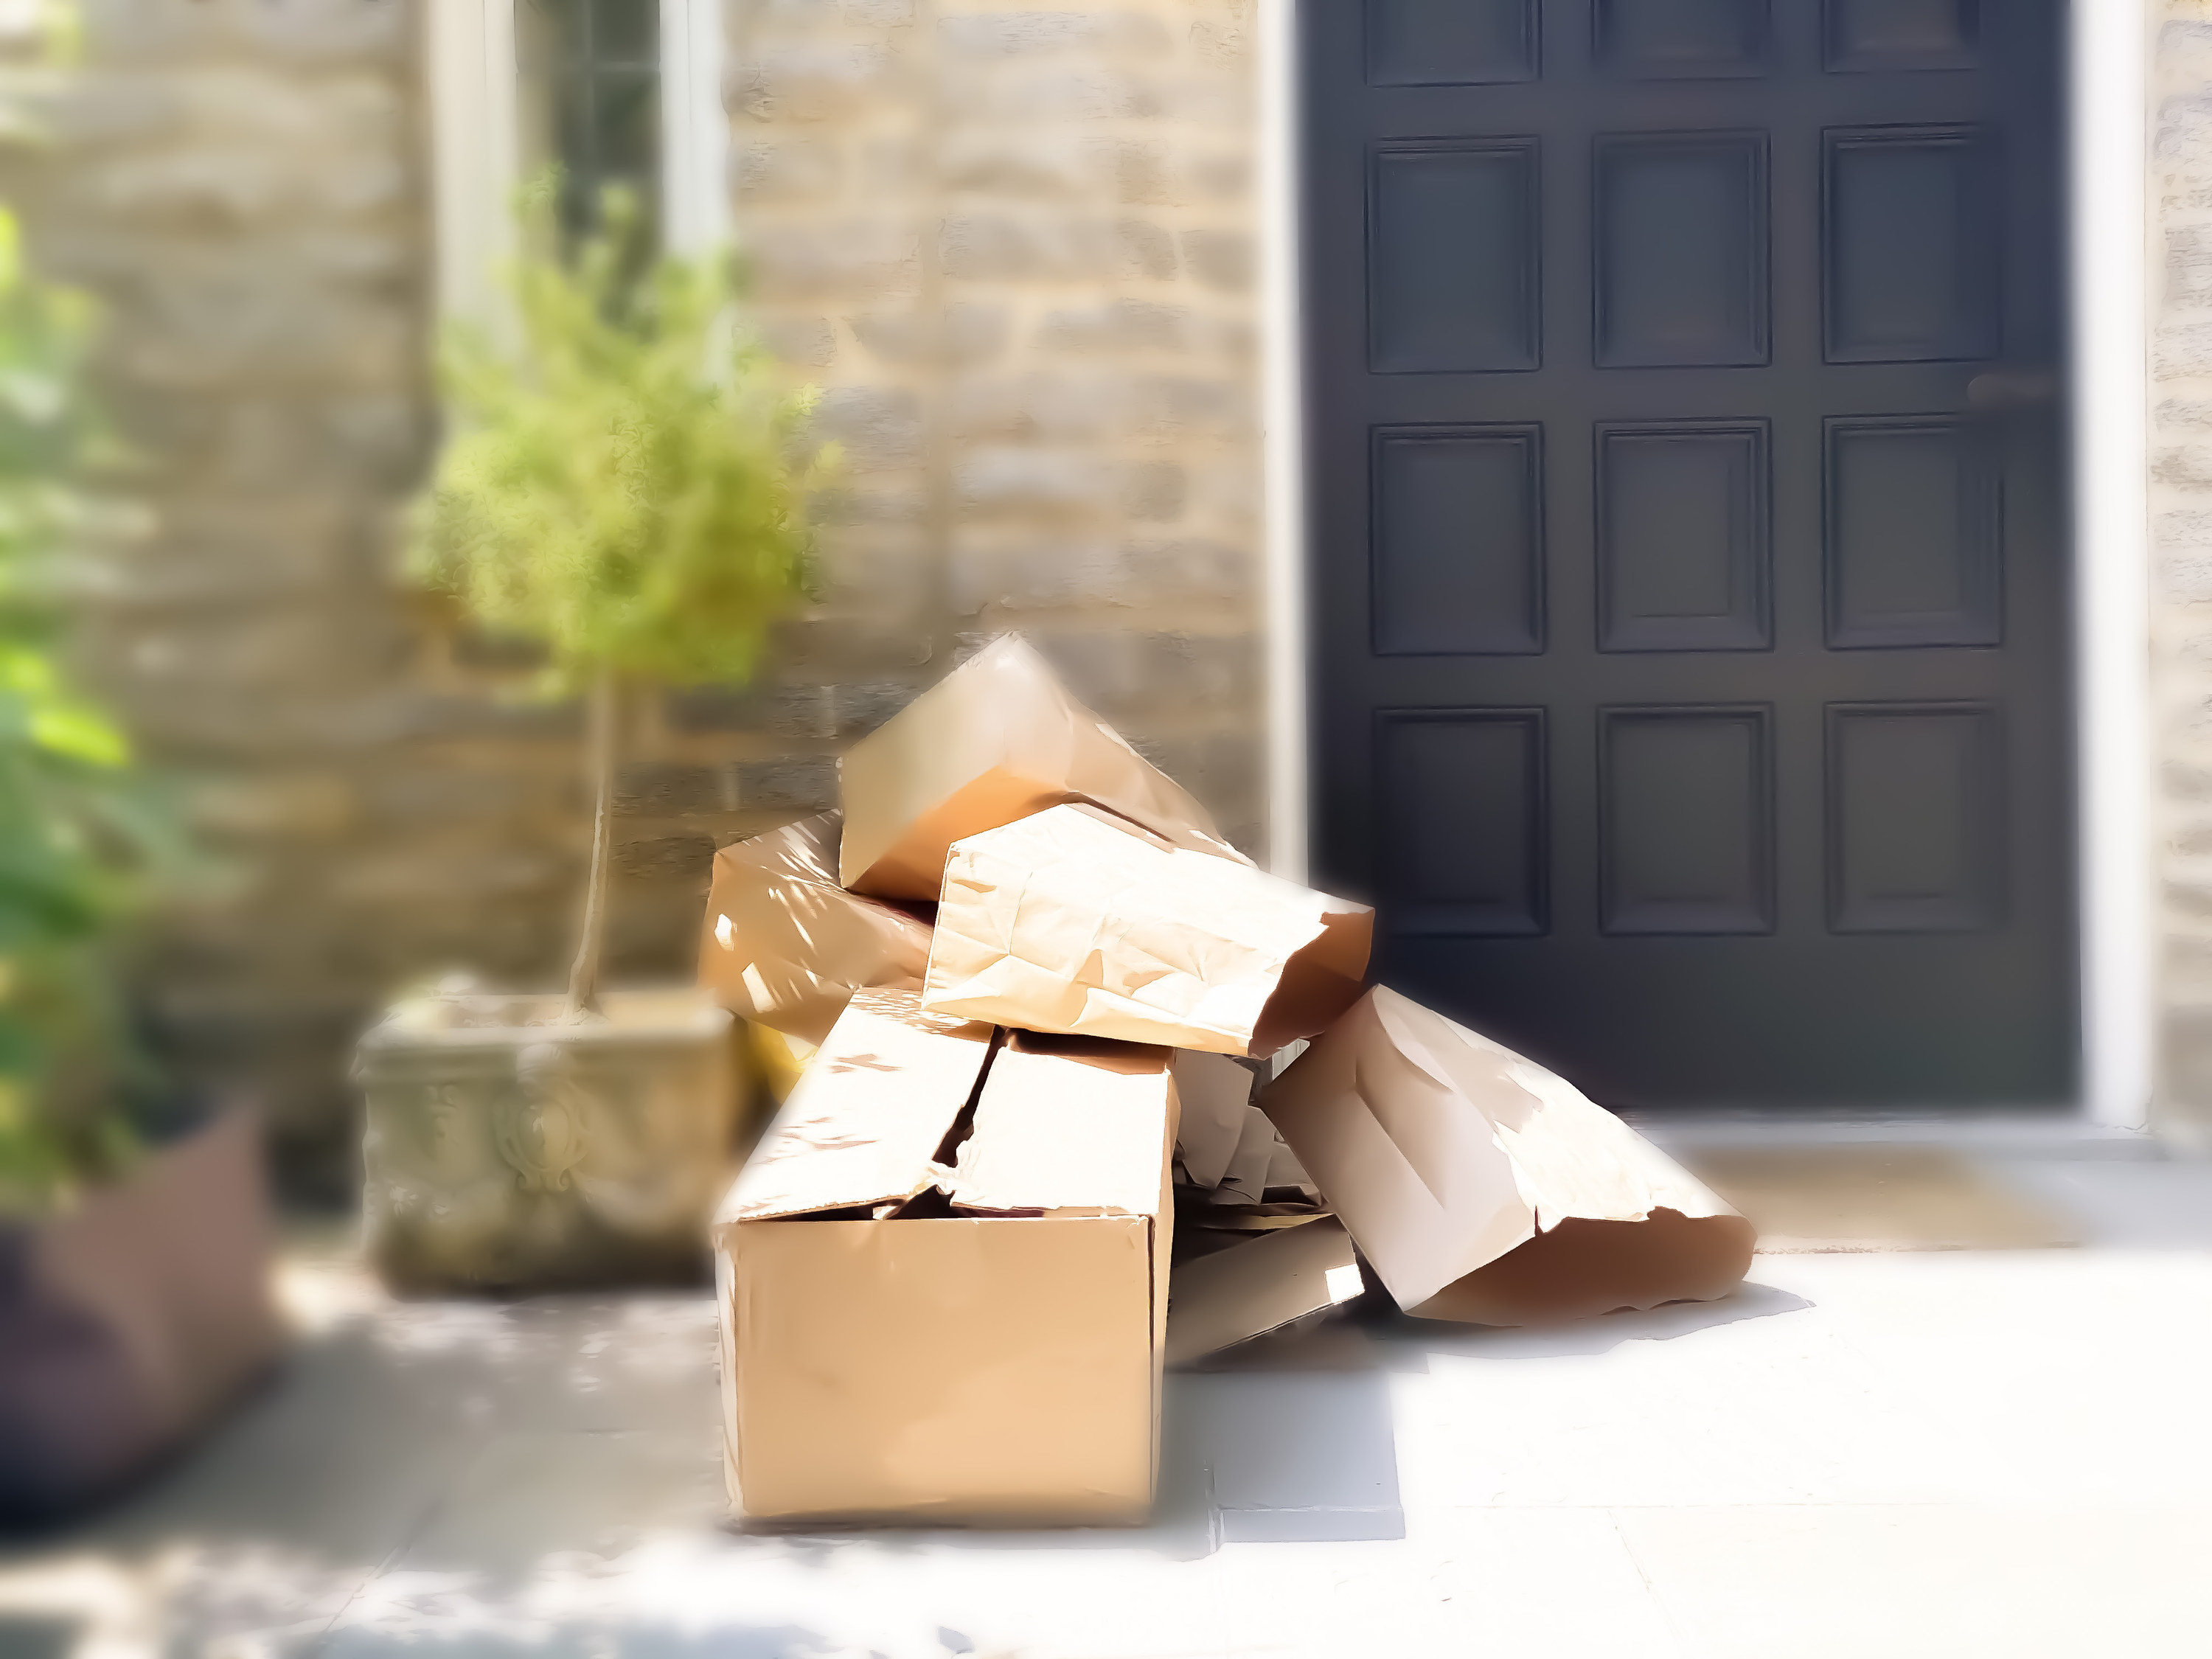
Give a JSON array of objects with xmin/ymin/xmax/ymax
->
[{"xmin": 699, "ymin": 812, "xmax": 929, "ymax": 1042}]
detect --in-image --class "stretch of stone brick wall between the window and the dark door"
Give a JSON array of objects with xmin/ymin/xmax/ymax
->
[{"xmin": 730, "ymin": 0, "xmax": 1261, "ymax": 847}]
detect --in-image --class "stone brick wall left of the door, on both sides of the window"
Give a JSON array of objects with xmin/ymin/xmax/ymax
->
[{"xmin": 0, "ymin": 0, "xmax": 1261, "ymax": 1197}]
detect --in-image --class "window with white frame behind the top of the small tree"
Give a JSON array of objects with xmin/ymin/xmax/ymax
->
[{"xmin": 427, "ymin": 0, "xmax": 730, "ymax": 323}]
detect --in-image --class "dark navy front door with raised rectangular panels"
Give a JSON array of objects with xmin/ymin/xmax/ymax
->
[{"xmin": 1301, "ymin": 0, "xmax": 2079, "ymax": 1110}]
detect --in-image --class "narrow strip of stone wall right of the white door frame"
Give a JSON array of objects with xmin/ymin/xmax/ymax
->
[{"xmin": 2150, "ymin": 0, "xmax": 2212, "ymax": 1139}]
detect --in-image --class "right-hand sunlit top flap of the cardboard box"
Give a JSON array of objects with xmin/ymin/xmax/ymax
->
[{"xmin": 945, "ymin": 1044, "xmax": 1175, "ymax": 1217}]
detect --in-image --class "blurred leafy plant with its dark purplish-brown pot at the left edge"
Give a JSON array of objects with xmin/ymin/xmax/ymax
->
[{"xmin": 0, "ymin": 210, "xmax": 279, "ymax": 1517}]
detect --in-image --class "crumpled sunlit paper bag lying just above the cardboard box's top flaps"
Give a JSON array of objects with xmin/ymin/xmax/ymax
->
[{"xmin": 922, "ymin": 805, "xmax": 1374, "ymax": 1055}]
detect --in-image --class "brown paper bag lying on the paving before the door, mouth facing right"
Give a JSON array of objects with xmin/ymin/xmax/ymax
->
[{"xmin": 1261, "ymin": 987, "xmax": 1754, "ymax": 1325}]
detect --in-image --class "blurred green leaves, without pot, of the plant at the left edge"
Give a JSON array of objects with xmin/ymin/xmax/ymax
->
[{"xmin": 0, "ymin": 210, "xmax": 181, "ymax": 1210}]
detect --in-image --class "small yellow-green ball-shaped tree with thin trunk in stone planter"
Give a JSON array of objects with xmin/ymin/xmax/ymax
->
[{"xmin": 414, "ymin": 184, "xmax": 827, "ymax": 1018}]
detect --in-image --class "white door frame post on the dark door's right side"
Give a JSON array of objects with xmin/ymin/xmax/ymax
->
[{"xmin": 2068, "ymin": 0, "xmax": 2157, "ymax": 1128}]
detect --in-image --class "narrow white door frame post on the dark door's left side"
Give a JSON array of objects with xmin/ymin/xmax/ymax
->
[{"xmin": 1259, "ymin": 0, "xmax": 1312, "ymax": 898}]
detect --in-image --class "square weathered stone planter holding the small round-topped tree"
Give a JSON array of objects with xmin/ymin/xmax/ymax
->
[{"xmin": 354, "ymin": 987, "xmax": 739, "ymax": 1292}]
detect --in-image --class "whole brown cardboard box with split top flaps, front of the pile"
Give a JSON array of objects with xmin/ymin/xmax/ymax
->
[{"xmin": 714, "ymin": 991, "xmax": 1175, "ymax": 1524}]
